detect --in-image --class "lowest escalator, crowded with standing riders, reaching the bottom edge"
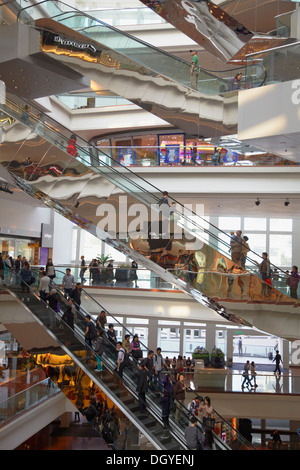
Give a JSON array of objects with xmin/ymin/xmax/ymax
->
[{"xmin": 1, "ymin": 275, "xmax": 229, "ymax": 450}]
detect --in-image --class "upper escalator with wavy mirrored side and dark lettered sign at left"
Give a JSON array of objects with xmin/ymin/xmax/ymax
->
[{"xmin": 0, "ymin": 2, "xmax": 264, "ymax": 137}]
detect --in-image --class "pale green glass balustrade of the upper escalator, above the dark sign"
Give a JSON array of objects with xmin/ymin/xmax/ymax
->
[{"xmin": 15, "ymin": 0, "xmax": 265, "ymax": 94}]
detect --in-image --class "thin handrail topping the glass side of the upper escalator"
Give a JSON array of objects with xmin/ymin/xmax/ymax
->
[{"xmin": 17, "ymin": 0, "xmax": 265, "ymax": 86}]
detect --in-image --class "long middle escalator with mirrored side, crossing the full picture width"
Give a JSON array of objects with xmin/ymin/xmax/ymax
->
[{"xmin": 0, "ymin": 86, "xmax": 299, "ymax": 339}]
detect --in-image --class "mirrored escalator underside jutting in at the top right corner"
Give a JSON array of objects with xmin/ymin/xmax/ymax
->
[{"xmin": 141, "ymin": 0, "xmax": 289, "ymax": 63}]
